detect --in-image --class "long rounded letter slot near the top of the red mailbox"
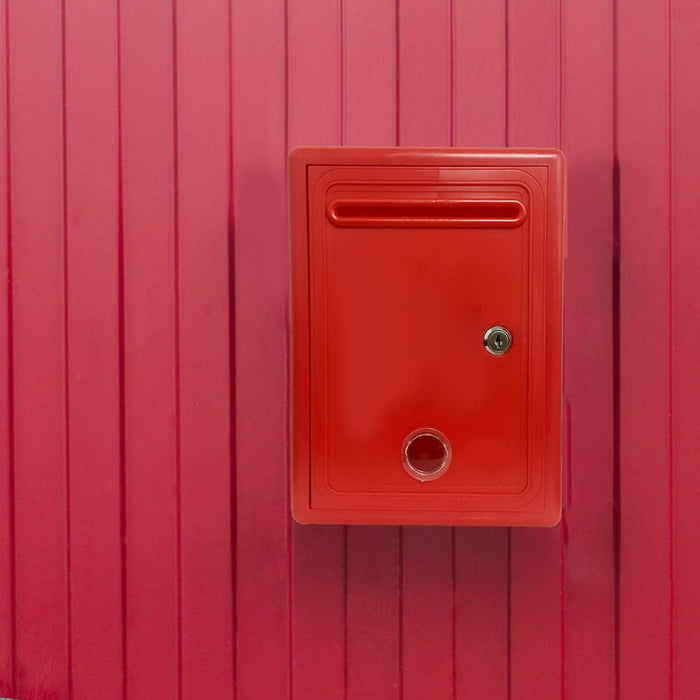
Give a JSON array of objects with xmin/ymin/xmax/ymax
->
[{"xmin": 328, "ymin": 199, "xmax": 527, "ymax": 228}]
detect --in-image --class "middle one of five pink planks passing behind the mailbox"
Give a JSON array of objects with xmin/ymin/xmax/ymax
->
[{"xmin": 397, "ymin": 0, "xmax": 454, "ymax": 699}]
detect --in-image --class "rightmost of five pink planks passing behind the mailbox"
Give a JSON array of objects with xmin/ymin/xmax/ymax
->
[{"xmin": 507, "ymin": 0, "xmax": 563, "ymax": 698}]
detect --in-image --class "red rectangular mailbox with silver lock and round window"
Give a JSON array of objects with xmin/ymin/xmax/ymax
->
[{"xmin": 289, "ymin": 148, "xmax": 564, "ymax": 526}]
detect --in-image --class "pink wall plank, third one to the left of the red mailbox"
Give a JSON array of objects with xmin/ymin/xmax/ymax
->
[{"xmin": 121, "ymin": 0, "xmax": 180, "ymax": 700}]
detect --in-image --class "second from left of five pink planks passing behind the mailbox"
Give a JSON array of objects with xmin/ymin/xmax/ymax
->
[{"xmin": 345, "ymin": 0, "xmax": 402, "ymax": 700}]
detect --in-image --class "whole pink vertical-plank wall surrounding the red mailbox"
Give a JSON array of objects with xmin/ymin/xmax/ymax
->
[{"xmin": 0, "ymin": 0, "xmax": 700, "ymax": 700}]
